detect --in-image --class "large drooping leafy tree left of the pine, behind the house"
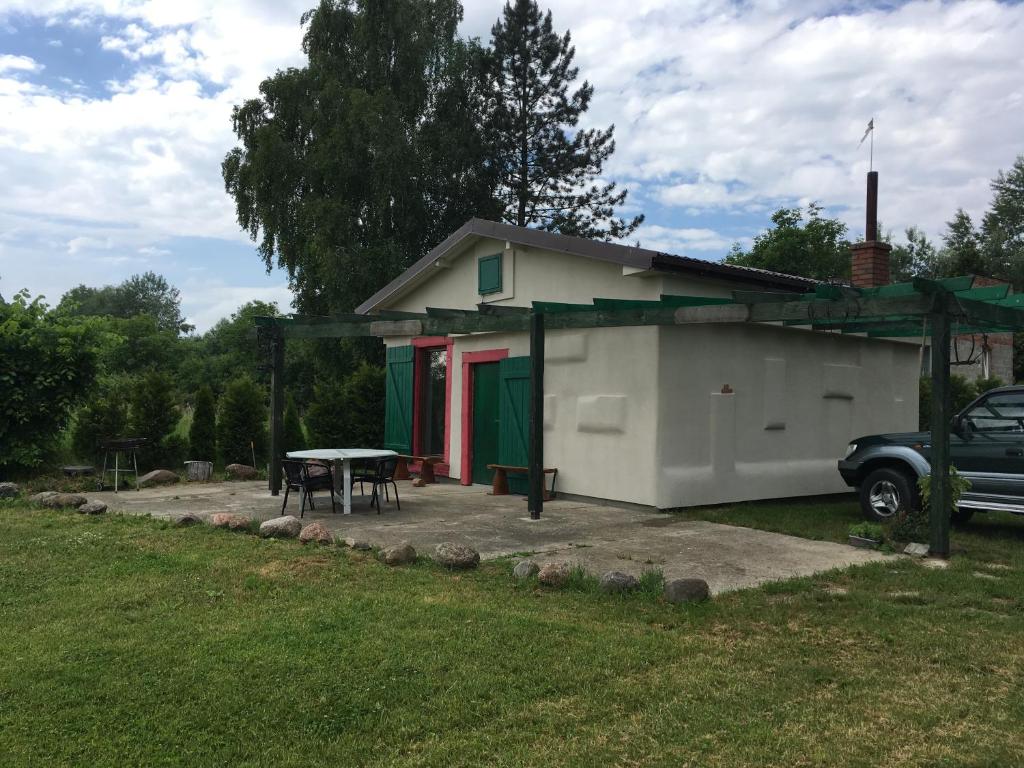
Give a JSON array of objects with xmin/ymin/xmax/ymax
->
[{"xmin": 222, "ymin": 0, "xmax": 496, "ymax": 313}]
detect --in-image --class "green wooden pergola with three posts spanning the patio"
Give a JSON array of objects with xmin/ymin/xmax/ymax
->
[{"xmin": 256, "ymin": 275, "xmax": 1024, "ymax": 556}]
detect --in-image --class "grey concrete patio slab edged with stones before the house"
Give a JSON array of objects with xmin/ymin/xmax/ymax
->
[{"xmin": 89, "ymin": 481, "xmax": 886, "ymax": 593}]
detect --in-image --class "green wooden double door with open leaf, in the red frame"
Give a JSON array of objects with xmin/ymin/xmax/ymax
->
[{"xmin": 472, "ymin": 357, "xmax": 529, "ymax": 494}]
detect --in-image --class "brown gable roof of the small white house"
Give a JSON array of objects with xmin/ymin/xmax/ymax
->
[{"xmin": 355, "ymin": 218, "xmax": 817, "ymax": 314}]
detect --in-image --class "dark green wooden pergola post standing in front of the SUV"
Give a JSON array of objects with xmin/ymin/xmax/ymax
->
[{"xmin": 929, "ymin": 309, "xmax": 952, "ymax": 557}]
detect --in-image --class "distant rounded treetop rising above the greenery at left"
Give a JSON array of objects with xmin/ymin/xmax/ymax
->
[{"xmin": 58, "ymin": 271, "xmax": 195, "ymax": 336}]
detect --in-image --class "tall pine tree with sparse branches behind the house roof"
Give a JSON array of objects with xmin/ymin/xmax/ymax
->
[{"xmin": 483, "ymin": 0, "xmax": 643, "ymax": 240}]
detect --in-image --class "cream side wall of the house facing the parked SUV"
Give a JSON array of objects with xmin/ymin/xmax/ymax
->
[{"xmin": 656, "ymin": 325, "xmax": 918, "ymax": 509}]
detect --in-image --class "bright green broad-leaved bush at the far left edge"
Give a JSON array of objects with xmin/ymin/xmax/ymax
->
[{"xmin": 0, "ymin": 291, "xmax": 97, "ymax": 476}]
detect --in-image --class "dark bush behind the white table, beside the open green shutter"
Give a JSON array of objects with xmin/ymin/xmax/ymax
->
[{"xmin": 306, "ymin": 362, "xmax": 385, "ymax": 447}]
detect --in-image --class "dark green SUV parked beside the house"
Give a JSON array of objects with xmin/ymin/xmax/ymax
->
[{"xmin": 839, "ymin": 386, "xmax": 1024, "ymax": 521}]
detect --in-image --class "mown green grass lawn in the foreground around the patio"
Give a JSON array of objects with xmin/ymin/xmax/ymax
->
[{"xmin": 0, "ymin": 502, "xmax": 1024, "ymax": 767}]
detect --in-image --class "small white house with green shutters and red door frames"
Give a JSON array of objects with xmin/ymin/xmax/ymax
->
[{"xmin": 356, "ymin": 219, "xmax": 920, "ymax": 509}]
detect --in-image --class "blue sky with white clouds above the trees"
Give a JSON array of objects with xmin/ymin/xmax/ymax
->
[{"xmin": 0, "ymin": 0, "xmax": 1024, "ymax": 332}]
